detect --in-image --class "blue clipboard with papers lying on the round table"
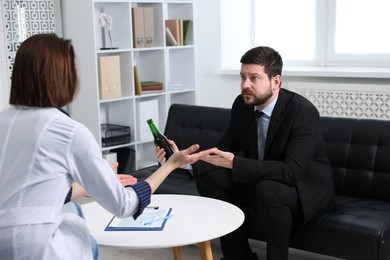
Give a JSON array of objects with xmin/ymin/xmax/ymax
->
[{"xmin": 104, "ymin": 208, "xmax": 173, "ymax": 231}]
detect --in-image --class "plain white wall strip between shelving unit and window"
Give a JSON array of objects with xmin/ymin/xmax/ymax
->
[{"xmin": 194, "ymin": 0, "xmax": 240, "ymax": 107}]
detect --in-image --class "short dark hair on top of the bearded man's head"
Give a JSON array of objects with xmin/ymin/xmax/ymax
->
[{"xmin": 240, "ymin": 46, "xmax": 283, "ymax": 79}]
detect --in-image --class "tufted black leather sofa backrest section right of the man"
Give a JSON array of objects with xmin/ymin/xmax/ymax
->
[{"xmin": 321, "ymin": 117, "xmax": 390, "ymax": 201}]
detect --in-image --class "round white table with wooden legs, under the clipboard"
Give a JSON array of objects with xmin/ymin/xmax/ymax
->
[{"xmin": 82, "ymin": 194, "xmax": 244, "ymax": 259}]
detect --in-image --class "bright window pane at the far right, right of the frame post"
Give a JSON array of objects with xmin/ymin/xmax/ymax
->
[{"xmin": 328, "ymin": 0, "xmax": 390, "ymax": 65}]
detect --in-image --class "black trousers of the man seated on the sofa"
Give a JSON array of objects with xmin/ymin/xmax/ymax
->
[{"xmin": 196, "ymin": 168, "xmax": 302, "ymax": 260}]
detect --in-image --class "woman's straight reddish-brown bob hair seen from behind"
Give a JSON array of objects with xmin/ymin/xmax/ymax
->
[{"xmin": 9, "ymin": 34, "xmax": 78, "ymax": 107}]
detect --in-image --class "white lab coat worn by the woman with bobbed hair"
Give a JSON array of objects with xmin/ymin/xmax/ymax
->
[{"xmin": 0, "ymin": 107, "xmax": 139, "ymax": 260}]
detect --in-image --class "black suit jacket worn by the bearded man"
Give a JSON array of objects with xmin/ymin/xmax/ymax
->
[{"xmin": 218, "ymin": 89, "xmax": 334, "ymax": 222}]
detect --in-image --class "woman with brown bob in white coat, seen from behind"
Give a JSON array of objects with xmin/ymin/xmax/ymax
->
[{"xmin": 0, "ymin": 34, "xmax": 213, "ymax": 260}]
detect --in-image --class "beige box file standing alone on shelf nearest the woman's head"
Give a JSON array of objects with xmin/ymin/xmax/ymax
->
[{"xmin": 98, "ymin": 55, "xmax": 122, "ymax": 100}]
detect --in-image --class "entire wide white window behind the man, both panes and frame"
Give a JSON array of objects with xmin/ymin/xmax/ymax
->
[{"xmin": 221, "ymin": 0, "xmax": 390, "ymax": 68}]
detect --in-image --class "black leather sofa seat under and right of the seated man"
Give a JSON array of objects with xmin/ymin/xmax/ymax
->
[{"xmin": 244, "ymin": 195, "xmax": 390, "ymax": 260}]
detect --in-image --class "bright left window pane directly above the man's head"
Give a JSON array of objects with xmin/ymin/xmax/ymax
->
[{"xmin": 254, "ymin": 0, "xmax": 316, "ymax": 63}]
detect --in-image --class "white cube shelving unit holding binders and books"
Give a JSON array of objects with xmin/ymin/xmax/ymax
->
[{"xmin": 61, "ymin": 0, "xmax": 196, "ymax": 169}]
